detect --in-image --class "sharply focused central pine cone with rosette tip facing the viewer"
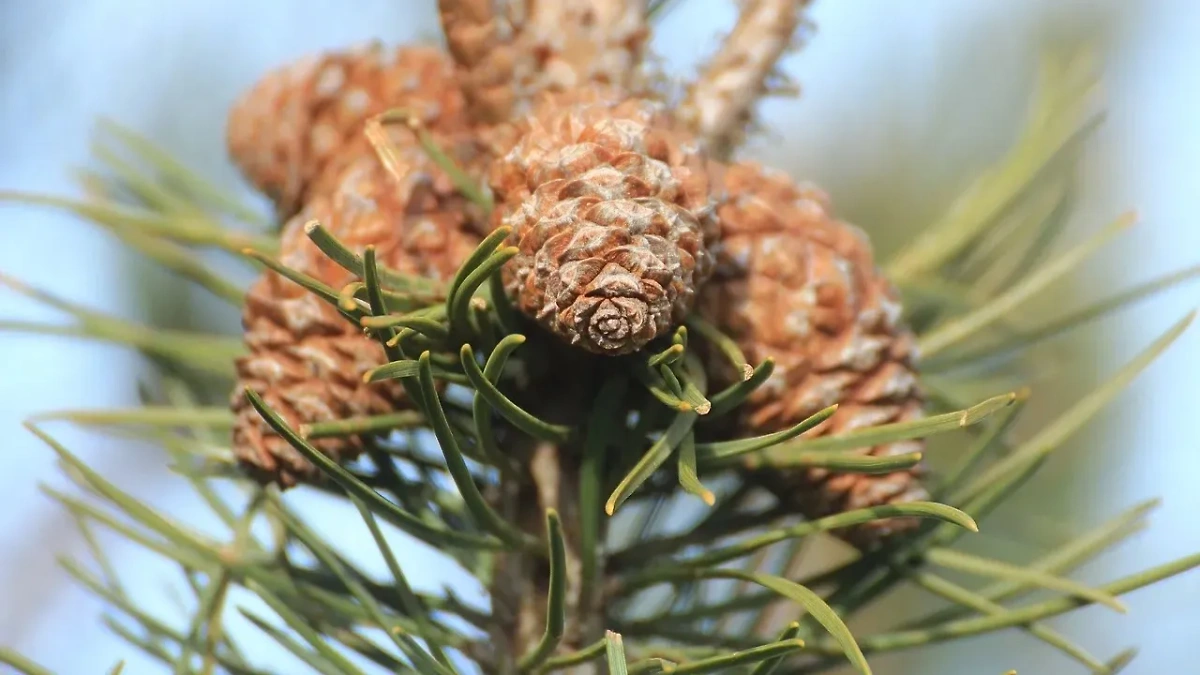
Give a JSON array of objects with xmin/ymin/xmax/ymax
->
[{"xmin": 491, "ymin": 89, "xmax": 716, "ymax": 354}]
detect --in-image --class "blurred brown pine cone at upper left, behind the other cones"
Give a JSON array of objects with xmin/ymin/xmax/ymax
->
[{"xmin": 227, "ymin": 42, "xmax": 467, "ymax": 219}]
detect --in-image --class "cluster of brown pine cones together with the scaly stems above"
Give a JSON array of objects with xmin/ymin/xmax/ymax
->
[{"xmin": 228, "ymin": 0, "xmax": 926, "ymax": 547}]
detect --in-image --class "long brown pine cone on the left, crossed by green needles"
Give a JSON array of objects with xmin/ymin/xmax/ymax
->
[{"xmin": 232, "ymin": 130, "xmax": 486, "ymax": 488}]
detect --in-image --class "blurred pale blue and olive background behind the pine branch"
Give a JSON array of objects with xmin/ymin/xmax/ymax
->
[{"xmin": 0, "ymin": 0, "xmax": 1200, "ymax": 675}]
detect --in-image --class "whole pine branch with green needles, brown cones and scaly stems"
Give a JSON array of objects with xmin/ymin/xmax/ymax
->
[{"xmin": 0, "ymin": 0, "xmax": 1200, "ymax": 675}]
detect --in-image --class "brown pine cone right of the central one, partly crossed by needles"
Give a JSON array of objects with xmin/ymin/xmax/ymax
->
[{"xmin": 700, "ymin": 163, "xmax": 928, "ymax": 548}]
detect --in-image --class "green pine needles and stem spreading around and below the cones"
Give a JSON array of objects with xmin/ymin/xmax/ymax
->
[{"xmin": 0, "ymin": 34, "xmax": 1200, "ymax": 675}]
